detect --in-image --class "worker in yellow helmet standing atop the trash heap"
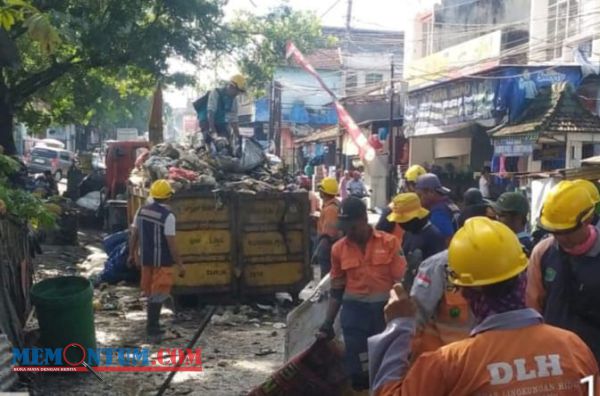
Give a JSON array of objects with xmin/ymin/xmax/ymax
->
[{"xmin": 194, "ymin": 74, "xmax": 246, "ymax": 154}]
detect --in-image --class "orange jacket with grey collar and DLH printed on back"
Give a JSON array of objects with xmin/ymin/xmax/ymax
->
[{"xmin": 369, "ymin": 309, "xmax": 600, "ymax": 396}]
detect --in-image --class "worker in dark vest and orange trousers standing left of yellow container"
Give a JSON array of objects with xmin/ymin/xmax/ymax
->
[{"xmin": 128, "ymin": 179, "xmax": 185, "ymax": 343}]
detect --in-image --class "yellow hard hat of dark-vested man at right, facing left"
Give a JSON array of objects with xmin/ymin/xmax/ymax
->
[{"xmin": 539, "ymin": 180, "xmax": 598, "ymax": 232}]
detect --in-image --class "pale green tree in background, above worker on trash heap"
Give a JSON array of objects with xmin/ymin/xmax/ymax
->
[{"xmin": 232, "ymin": 5, "xmax": 335, "ymax": 95}]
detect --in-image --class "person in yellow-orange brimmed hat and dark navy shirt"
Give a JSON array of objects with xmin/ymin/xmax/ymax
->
[{"xmin": 388, "ymin": 193, "xmax": 446, "ymax": 290}]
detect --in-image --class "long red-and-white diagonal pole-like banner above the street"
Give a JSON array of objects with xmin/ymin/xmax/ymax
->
[{"xmin": 286, "ymin": 42, "xmax": 375, "ymax": 161}]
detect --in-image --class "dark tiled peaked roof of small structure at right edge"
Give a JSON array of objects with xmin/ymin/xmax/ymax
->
[{"xmin": 490, "ymin": 84, "xmax": 600, "ymax": 137}]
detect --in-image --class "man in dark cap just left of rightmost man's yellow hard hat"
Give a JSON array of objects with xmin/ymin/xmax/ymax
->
[{"xmin": 494, "ymin": 192, "xmax": 533, "ymax": 257}]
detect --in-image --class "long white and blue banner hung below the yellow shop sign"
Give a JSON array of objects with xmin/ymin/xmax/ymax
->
[{"xmin": 404, "ymin": 66, "xmax": 582, "ymax": 137}]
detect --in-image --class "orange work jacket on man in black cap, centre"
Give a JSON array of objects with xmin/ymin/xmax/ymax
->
[{"xmin": 330, "ymin": 230, "xmax": 406, "ymax": 301}]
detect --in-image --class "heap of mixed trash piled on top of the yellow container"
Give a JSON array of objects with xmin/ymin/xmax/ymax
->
[{"xmin": 130, "ymin": 138, "xmax": 295, "ymax": 194}]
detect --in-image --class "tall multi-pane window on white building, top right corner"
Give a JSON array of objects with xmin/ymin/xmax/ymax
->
[{"xmin": 547, "ymin": 0, "xmax": 580, "ymax": 60}]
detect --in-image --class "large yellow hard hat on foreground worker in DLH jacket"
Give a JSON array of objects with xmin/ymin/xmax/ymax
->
[{"xmin": 448, "ymin": 217, "xmax": 528, "ymax": 287}]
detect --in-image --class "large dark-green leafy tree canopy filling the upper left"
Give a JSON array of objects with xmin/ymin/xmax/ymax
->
[{"xmin": 0, "ymin": 0, "xmax": 227, "ymax": 154}]
